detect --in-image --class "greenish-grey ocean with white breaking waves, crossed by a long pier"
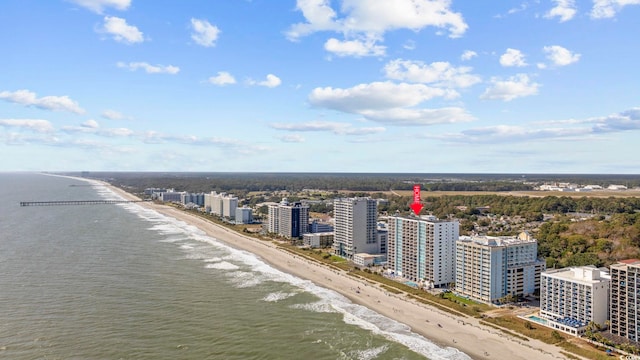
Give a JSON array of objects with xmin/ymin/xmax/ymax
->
[{"xmin": 0, "ymin": 173, "xmax": 469, "ymax": 360}]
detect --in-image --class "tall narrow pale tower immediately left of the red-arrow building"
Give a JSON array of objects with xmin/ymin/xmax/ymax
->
[{"xmin": 333, "ymin": 197, "xmax": 380, "ymax": 259}]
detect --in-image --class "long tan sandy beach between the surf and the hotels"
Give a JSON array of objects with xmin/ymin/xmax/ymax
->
[{"xmin": 109, "ymin": 186, "xmax": 580, "ymax": 360}]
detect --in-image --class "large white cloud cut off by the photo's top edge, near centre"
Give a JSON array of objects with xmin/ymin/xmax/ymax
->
[{"xmin": 287, "ymin": 0, "xmax": 468, "ymax": 50}]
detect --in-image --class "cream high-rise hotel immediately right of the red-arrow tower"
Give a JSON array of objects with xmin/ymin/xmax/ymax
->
[{"xmin": 455, "ymin": 232, "xmax": 545, "ymax": 303}]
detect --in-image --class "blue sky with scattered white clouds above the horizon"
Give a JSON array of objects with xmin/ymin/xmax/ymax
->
[{"xmin": 0, "ymin": 0, "xmax": 640, "ymax": 174}]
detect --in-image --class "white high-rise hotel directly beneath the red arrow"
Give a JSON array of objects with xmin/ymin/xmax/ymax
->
[{"xmin": 387, "ymin": 216, "xmax": 460, "ymax": 288}]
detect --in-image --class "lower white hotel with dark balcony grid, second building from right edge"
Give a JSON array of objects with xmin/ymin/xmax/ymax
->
[{"xmin": 540, "ymin": 265, "xmax": 611, "ymax": 336}]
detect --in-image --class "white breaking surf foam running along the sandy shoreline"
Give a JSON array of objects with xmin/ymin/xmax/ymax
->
[{"xmin": 84, "ymin": 179, "xmax": 470, "ymax": 360}]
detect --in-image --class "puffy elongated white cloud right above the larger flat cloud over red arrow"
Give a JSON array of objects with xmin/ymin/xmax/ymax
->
[{"xmin": 384, "ymin": 59, "xmax": 481, "ymax": 88}]
